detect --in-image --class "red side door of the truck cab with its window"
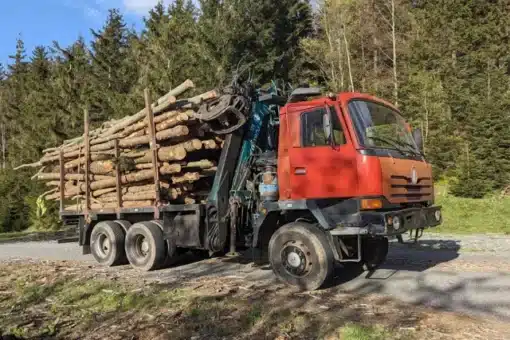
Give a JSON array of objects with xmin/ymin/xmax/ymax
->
[{"xmin": 289, "ymin": 104, "xmax": 357, "ymax": 199}]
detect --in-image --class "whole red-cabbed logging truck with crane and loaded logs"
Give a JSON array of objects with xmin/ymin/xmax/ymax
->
[{"xmin": 39, "ymin": 81, "xmax": 442, "ymax": 290}]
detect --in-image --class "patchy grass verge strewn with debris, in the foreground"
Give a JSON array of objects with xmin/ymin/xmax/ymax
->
[{"xmin": 0, "ymin": 263, "xmax": 426, "ymax": 340}]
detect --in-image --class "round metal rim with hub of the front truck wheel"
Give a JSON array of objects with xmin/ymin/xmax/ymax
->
[{"xmin": 281, "ymin": 241, "xmax": 313, "ymax": 277}]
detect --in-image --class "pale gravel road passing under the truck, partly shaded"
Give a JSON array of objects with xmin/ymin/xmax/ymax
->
[{"xmin": 0, "ymin": 234, "xmax": 510, "ymax": 320}]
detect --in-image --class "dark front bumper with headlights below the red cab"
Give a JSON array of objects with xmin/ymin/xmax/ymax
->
[{"xmin": 330, "ymin": 206, "xmax": 443, "ymax": 236}]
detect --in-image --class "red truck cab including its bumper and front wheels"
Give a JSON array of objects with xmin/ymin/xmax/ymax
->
[{"xmin": 256, "ymin": 91, "xmax": 442, "ymax": 289}]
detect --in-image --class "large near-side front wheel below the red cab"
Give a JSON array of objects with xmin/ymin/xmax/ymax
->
[{"xmin": 269, "ymin": 222, "xmax": 334, "ymax": 290}]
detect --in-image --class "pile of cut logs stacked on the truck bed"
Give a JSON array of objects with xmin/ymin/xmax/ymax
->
[{"xmin": 17, "ymin": 80, "xmax": 223, "ymax": 211}]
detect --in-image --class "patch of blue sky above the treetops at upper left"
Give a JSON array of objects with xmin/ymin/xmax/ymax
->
[{"xmin": 0, "ymin": 0, "xmax": 170, "ymax": 64}]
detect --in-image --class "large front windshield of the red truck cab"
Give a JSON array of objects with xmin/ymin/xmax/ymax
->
[{"xmin": 349, "ymin": 100, "xmax": 419, "ymax": 153}]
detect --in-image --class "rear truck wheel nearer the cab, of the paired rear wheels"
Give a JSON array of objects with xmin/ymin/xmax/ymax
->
[{"xmin": 126, "ymin": 222, "xmax": 166, "ymax": 271}]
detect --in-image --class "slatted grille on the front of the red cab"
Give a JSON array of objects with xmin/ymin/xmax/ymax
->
[{"xmin": 390, "ymin": 176, "xmax": 433, "ymax": 201}]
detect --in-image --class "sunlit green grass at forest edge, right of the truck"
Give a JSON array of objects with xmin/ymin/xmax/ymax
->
[{"xmin": 434, "ymin": 184, "xmax": 510, "ymax": 234}]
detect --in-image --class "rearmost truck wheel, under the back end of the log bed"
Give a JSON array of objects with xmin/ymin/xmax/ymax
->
[{"xmin": 90, "ymin": 221, "xmax": 126, "ymax": 267}]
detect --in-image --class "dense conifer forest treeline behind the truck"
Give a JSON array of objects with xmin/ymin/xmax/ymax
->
[{"xmin": 0, "ymin": 0, "xmax": 510, "ymax": 231}]
